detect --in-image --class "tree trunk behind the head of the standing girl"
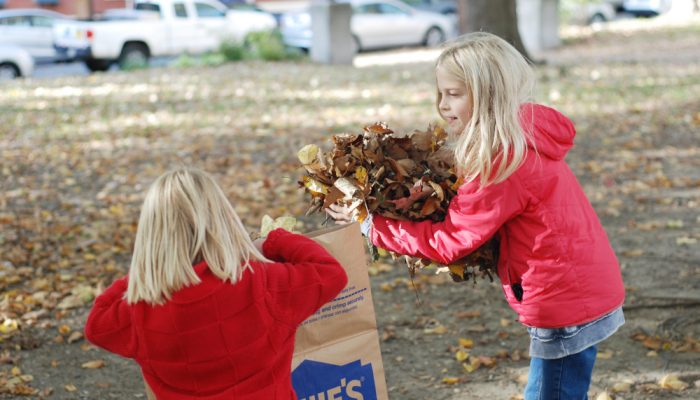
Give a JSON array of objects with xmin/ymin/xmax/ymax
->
[{"xmin": 457, "ymin": 0, "xmax": 530, "ymax": 60}]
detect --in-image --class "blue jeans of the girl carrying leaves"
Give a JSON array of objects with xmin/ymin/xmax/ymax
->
[{"xmin": 525, "ymin": 346, "xmax": 598, "ymax": 400}]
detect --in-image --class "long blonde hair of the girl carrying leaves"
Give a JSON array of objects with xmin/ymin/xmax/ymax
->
[{"xmin": 435, "ymin": 32, "xmax": 534, "ymax": 187}]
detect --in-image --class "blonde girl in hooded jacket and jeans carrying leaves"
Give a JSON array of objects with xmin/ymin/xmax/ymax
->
[{"xmin": 329, "ymin": 33, "xmax": 624, "ymax": 400}]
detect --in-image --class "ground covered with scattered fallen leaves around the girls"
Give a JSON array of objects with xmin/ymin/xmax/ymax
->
[{"xmin": 0, "ymin": 20, "xmax": 700, "ymax": 400}]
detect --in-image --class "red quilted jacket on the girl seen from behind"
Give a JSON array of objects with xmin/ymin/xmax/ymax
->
[{"xmin": 85, "ymin": 229, "xmax": 347, "ymax": 400}]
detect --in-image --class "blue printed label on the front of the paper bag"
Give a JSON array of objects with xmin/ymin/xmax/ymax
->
[{"xmin": 292, "ymin": 360, "xmax": 377, "ymax": 400}]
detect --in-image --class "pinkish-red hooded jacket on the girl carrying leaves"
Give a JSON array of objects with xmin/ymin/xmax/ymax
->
[{"xmin": 370, "ymin": 104, "xmax": 625, "ymax": 328}]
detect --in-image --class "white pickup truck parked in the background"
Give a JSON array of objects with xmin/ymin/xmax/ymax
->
[{"xmin": 53, "ymin": 0, "xmax": 277, "ymax": 71}]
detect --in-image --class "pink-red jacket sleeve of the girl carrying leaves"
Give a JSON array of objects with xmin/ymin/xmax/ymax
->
[{"xmin": 370, "ymin": 174, "xmax": 528, "ymax": 265}]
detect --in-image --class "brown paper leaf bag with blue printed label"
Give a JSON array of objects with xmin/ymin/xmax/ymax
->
[{"xmin": 292, "ymin": 223, "xmax": 388, "ymax": 400}]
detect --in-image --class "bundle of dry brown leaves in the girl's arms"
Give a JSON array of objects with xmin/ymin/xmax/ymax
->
[{"xmin": 298, "ymin": 123, "xmax": 498, "ymax": 282}]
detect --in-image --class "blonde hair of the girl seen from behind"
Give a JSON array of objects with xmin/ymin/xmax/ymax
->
[{"xmin": 126, "ymin": 168, "xmax": 267, "ymax": 304}]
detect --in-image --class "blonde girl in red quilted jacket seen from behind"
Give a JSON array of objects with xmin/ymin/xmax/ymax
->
[{"xmin": 85, "ymin": 169, "xmax": 347, "ymax": 400}]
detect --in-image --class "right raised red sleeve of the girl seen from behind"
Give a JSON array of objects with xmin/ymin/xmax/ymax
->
[{"xmin": 263, "ymin": 229, "xmax": 348, "ymax": 325}]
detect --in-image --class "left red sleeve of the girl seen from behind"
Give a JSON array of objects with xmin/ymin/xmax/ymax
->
[{"xmin": 85, "ymin": 276, "xmax": 136, "ymax": 358}]
